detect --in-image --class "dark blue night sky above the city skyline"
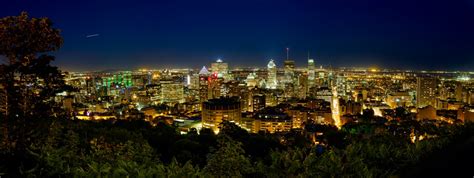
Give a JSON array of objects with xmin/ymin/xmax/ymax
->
[{"xmin": 0, "ymin": 0, "xmax": 474, "ymax": 71}]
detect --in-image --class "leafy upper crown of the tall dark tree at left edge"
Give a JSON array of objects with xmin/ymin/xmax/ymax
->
[{"xmin": 0, "ymin": 12, "xmax": 64, "ymax": 118}]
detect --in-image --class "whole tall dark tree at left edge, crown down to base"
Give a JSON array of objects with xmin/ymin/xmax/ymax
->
[{"xmin": 0, "ymin": 12, "xmax": 67, "ymax": 176}]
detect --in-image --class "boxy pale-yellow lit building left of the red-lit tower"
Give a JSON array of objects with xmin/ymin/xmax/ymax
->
[{"xmin": 160, "ymin": 80, "xmax": 184, "ymax": 105}]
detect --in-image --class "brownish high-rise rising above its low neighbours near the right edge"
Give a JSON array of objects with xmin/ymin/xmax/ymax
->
[{"xmin": 416, "ymin": 77, "xmax": 437, "ymax": 108}]
